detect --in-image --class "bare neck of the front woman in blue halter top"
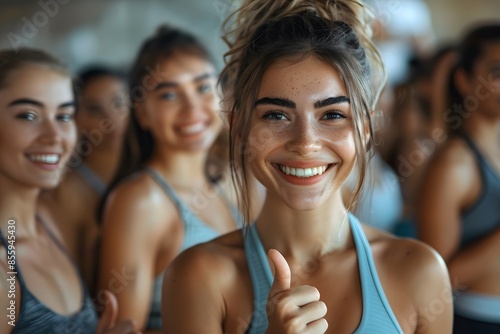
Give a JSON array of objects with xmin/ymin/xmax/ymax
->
[{"xmin": 256, "ymin": 191, "xmax": 350, "ymax": 263}]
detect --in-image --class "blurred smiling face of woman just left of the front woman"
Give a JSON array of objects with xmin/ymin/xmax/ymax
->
[{"xmin": 137, "ymin": 52, "xmax": 222, "ymax": 152}]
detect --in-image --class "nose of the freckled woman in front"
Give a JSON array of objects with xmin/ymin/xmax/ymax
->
[{"xmin": 286, "ymin": 117, "xmax": 322, "ymax": 156}]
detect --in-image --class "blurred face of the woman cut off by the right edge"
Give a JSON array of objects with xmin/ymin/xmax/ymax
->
[{"xmin": 462, "ymin": 42, "xmax": 500, "ymax": 118}]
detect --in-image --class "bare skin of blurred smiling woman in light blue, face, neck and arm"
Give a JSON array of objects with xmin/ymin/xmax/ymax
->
[{"xmin": 99, "ymin": 53, "xmax": 240, "ymax": 328}]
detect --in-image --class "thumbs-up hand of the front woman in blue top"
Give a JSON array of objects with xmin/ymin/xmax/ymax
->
[{"xmin": 266, "ymin": 249, "xmax": 328, "ymax": 334}]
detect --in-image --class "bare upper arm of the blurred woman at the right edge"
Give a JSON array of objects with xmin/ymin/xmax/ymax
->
[{"xmin": 417, "ymin": 144, "xmax": 472, "ymax": 261}]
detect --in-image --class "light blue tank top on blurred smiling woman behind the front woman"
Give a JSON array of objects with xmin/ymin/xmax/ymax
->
[{"xmin": 145, "ymin": 167, "xmax": 242, "ymax": 330}]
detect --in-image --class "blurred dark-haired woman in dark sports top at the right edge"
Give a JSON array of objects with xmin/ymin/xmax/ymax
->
[{"xmin": 417, "ymin": 22, "xmax": 500, "ymax": 333}]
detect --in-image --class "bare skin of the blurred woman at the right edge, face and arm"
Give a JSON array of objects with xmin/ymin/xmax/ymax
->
[{"xmin": 418, "ymin": 43, "xmax": 500, "ymax": 296}]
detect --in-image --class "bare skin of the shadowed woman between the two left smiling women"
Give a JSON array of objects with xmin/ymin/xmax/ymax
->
[{"xmin": 40, "ymin": 76, "xmax": 129, "ymax": 286}]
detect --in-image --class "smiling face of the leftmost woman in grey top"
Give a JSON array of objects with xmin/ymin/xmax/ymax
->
[{"xmin": 0, "ymin": 65, "xmax": 76, "ymax": 188}]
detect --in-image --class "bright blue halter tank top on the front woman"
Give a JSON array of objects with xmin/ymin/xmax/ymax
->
[{"xmin": 245, "ymin": 214, "xmax": 403, "ymax": 334}]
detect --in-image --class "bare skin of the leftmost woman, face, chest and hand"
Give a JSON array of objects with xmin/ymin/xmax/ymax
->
[{"xmin": 0, "ymin": 65, "xmax": 137, "ymax": 333}]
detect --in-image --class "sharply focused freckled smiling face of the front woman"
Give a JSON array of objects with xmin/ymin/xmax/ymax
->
[{"xmin": 247, "ymin": 57, "xmax": 356, "ymax": 210}]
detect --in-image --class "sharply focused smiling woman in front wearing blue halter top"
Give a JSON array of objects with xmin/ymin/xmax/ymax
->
[{"xmin": 162, "ymin": 0, "xmax": 452, "ymax": 334}]
